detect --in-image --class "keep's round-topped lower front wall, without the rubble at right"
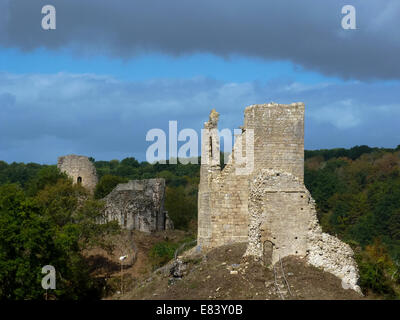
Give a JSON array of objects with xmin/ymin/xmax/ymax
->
[{"xmin": 246, "ymin": 169, "xmax": 314, "ymax": 263}]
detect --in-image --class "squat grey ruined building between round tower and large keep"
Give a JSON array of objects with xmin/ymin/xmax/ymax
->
[{"xmin": 103, "ymin": 179, "xmax": 173, "ymax": 232}]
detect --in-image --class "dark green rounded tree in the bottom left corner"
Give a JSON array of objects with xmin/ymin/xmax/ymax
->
[{"xmin": 0, "ymin": 185, "xmax": 54, "ymax": 300}]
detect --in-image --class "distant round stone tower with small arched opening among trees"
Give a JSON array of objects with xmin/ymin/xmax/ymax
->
[{"xmin": 57, "ymin": 154, "xmax": 98, "ymax": 193}]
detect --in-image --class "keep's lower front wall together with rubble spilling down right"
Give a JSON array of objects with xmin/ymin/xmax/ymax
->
[{"xmin": 245, "ymin": 169, "xmax": 361, "ymax": 292}]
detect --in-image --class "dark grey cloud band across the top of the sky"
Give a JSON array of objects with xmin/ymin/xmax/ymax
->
[{"xmin": 0, "ymin": 0, "xmax": 400, "ymax": 80}]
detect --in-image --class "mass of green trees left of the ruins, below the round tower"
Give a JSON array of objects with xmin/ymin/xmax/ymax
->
[{"xmin": 0, "ymin": 164, "xmax": 118, "ymax": 300}]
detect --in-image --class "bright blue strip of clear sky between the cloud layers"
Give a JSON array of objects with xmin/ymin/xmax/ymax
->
[{"xmin": 0, "ymin": 48, "xmax": 339, "ymax": 83}]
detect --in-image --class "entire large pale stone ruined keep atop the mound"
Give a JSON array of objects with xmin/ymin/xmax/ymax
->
[{"xmin": 198, "ymin": 103, "xmax": 360, "ymax": 292}]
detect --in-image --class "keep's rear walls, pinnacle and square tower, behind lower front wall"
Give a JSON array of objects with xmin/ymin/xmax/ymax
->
[{"xmin": 198, "ymin": 103, "xmax": 304, "ymax": 248}]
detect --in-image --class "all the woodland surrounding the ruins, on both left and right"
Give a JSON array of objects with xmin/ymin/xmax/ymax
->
[{"xmin": 0, "ymin": 146, "xmax": 400, "ymax": 299}]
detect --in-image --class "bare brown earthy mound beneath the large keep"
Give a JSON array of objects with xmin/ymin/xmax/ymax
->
[{"xmin": 119, "ymin": 244, "xmax": 365, "ymax": 300}]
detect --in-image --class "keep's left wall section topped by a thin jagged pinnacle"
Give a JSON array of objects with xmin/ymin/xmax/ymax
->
[{"xmin": 198, "ymin": 110, "xmax": 248, "ymax": 248}]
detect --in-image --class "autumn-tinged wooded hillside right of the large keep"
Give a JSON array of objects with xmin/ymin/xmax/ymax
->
[{"xmin": 304, "ymin": 146, "xmax": 400, "ymax": 297}]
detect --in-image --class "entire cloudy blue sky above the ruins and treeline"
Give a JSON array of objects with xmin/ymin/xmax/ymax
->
[{"xmin": 0, "ymin": 0, "xmax": 400, "ymax": 164}]
